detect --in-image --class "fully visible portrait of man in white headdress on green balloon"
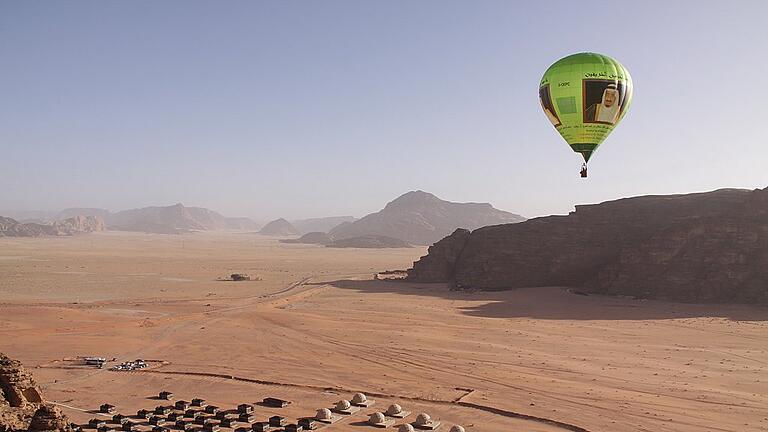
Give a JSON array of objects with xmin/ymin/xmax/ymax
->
[{"xmin": 582, "ymin": 79, "xmax": 626, "ymax": 125}]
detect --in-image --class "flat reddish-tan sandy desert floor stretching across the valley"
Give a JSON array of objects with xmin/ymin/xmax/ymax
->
[{"xmin": 0, "ymin": 233, "xmax": 768, "ymax": 432}]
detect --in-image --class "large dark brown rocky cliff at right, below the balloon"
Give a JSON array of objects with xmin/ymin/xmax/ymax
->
[{"xmin": 408, "ymin": 189, "xmax": 768, "ymax": 304}]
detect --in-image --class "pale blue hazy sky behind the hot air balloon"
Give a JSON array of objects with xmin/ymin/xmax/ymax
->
[{"xmin": 0, "ymin": 0, "xmax": 768, "ymax": 219}]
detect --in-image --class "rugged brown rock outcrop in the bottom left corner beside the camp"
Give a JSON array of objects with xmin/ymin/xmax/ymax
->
[{"xmin": 0, "ymin": 353, "xmax": 72, "ymax": 432}]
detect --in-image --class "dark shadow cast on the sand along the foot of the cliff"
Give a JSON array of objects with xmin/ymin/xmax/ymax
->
[{"xmin": 316, "ymin": 280, "xmax": 768, "ymax": 321}]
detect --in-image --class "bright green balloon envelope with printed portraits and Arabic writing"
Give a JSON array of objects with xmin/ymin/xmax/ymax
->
[{"xmin": 539, "ymin": 53, "xmax": 632, "ymax": 162}]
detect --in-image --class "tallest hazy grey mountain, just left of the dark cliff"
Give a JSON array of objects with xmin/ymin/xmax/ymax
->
[{"xmin": 329, "ymin": 191, "xmax": 525, "ymax": 245}]
